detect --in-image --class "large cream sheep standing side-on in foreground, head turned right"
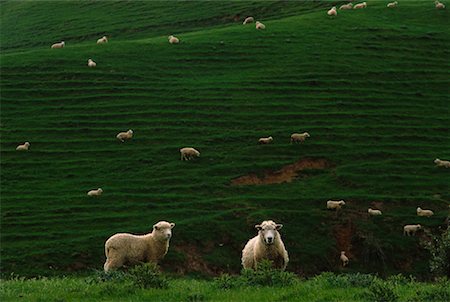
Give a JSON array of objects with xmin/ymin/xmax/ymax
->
[{"xmin": 103, "ymin": 221, "xmax": 175, "ymax": 272}]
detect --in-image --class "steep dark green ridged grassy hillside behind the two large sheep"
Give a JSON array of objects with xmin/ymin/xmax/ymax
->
[{"xmin": 0, "ymin": 1, "xmax": 450, "ymax": 276}]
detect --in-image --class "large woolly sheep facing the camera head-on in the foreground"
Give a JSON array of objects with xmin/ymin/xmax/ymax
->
[{"xmin": 242, "ymin": 220, "xmax": 289, "ymax": 270}]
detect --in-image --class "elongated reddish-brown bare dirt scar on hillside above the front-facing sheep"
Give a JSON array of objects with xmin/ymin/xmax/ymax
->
[{"xmin": 231, "ymin": 158, "xmax": 332, "ymax": 186}]
